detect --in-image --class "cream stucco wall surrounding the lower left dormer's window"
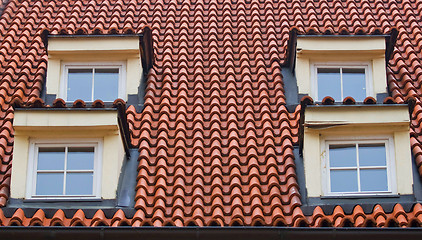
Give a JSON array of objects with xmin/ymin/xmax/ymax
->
[{"xmin": 10, "ymin": 109, "xmax": 124, "ymax": 199}]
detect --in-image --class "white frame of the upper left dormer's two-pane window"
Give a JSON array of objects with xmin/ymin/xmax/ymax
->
[{"xmin": 60, "ymin": 61, "xmax": 126, "ymax": 102}]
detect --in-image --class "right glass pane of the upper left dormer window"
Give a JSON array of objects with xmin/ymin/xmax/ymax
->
[{"xmin": 94, "ymin": 68, "xmax": 119, "ymax": 102}]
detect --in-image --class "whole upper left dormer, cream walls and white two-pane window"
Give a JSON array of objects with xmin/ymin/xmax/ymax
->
[{"xmin": 46, "ymin": 35, "xmax": 144, "ymax": 104}]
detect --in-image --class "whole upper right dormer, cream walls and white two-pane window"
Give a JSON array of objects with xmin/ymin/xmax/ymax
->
[{"xmin": 295, "ymin": 36, "xmax": 387, "ymax": 102}]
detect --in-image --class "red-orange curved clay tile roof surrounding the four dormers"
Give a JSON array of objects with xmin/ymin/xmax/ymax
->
[{"xmin": 0, "ymin": 0, "xmax": 422, "ymax": 226}]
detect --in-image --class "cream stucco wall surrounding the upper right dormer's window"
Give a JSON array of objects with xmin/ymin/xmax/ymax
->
[{"xmin": 295, "ymin": 36, "xmax": 387, "ymax": 99}]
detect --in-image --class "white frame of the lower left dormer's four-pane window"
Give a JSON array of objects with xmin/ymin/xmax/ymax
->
[{"xmin": 26, "ymin": 138, "xmax": 103, "ymax": 200}]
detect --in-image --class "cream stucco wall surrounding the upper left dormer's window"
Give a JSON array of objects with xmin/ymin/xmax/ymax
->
[{"xmin": 46, "ymin": 36, "xmax": 143, "ymax": 100}]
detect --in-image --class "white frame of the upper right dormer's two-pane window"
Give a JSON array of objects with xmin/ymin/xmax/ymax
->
[{"xmin": 311, "ymin": 62, "xmax": 374, "ymax": 101}]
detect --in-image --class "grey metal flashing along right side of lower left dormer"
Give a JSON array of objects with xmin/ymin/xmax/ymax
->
[{"xmin": 117, "ymin": 149, "xmax": 139, "ymax": 207}]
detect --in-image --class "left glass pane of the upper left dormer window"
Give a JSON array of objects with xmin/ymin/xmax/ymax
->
[{"xmin": 67, "ymin": 69, "xmax": 92, "ymax": 101}]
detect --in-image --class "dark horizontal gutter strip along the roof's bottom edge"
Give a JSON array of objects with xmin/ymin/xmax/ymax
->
[{"xmin": 0, "ymin": 227, "xmax": 422, "ymax": 240}]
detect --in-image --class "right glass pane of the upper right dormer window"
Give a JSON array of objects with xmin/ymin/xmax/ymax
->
[{"xmin": 343, "ymin": 68, "xmax": 366, "ymax": 102}]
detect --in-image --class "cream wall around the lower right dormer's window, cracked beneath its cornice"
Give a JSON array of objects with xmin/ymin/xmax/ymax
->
[{"xmin": 303, "ymin": 105, "xmax": 413, "ymax": 197}]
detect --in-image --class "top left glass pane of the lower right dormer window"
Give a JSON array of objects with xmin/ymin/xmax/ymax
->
[{"xmin": 329, "ymin": 144, "xmax": 356, "ymax": 167}]
